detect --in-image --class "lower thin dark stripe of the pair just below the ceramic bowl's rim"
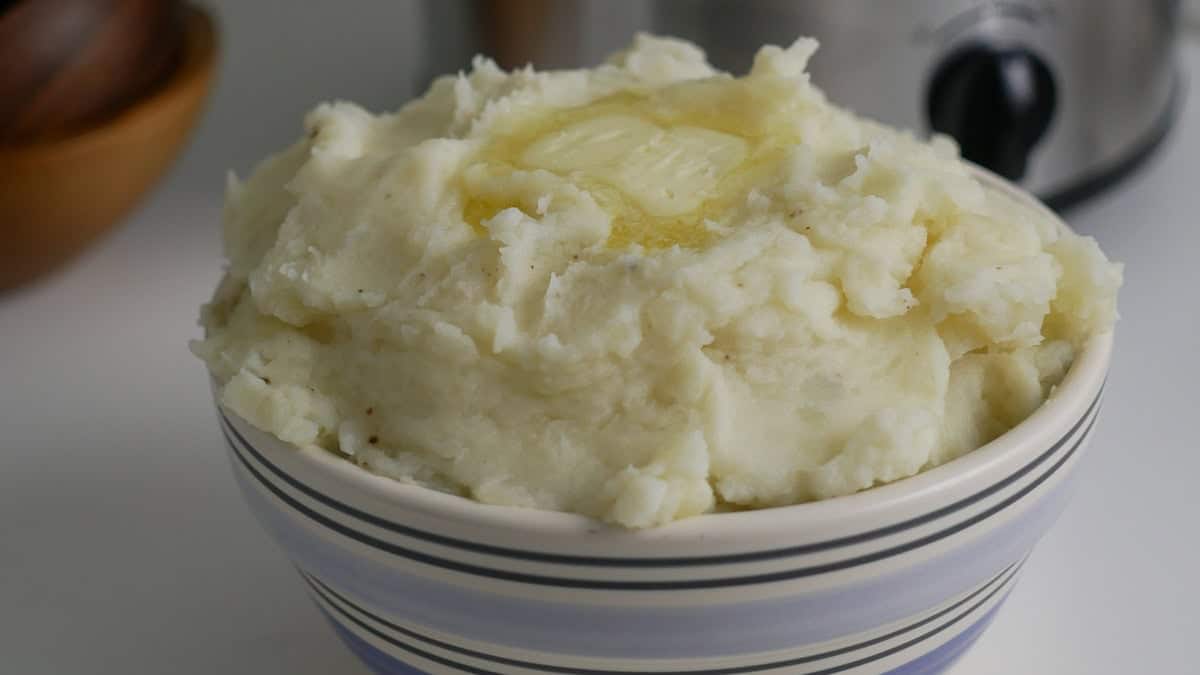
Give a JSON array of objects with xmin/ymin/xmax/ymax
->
[{"xmin": 213, "ymin": 395, "xmax": 1100, "ymax": 591}]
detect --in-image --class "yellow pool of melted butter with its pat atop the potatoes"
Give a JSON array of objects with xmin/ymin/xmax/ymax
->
[{"xmin": 462, "ymin": 78, "xmax": 797, "ymax": 249}]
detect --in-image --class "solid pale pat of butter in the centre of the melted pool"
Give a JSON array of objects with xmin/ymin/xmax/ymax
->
[{"xmin": 520, "ymin": 114, "xmax": 749, "ymax": 217}]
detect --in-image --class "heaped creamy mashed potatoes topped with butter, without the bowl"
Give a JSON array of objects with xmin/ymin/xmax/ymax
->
[{"xmin": 193, "ymin": 36, "xmax": 1121, "ymax": 527}]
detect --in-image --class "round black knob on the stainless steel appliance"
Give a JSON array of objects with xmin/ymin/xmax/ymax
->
[{"xmin": 926, "ymin": 44, "xmax": 1055, "ymax": 180}]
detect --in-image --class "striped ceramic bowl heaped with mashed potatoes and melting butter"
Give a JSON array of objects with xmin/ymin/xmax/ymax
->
[{"xmin": 192, "ymin": 36, "xmax": 1122, "ymax": 674}]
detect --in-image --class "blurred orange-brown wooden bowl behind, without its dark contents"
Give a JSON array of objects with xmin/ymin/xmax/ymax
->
[{"xmin": 0, "ymin": 8, "xmax": 217, "ymax": 288}]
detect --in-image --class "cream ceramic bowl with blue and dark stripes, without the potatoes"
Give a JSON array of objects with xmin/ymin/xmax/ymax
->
[{"xmin": 208, "ymin": 169, "xmax": 1112, "ymax": 675}]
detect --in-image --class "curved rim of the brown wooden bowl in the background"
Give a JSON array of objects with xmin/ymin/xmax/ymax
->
[{"xmin": 0, "ymin": 4, "xmax": 218, "ymax": 160}]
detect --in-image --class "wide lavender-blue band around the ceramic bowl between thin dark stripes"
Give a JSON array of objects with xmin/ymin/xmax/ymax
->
[{"xmin": 223, "ymin": 417, "xmax": 1070, "ymax": 658}]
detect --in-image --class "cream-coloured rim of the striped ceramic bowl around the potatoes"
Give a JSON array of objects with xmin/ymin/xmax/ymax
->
[{"xmin": 211, "ymin": 166, "xmax": 1114, "ymax": 544}]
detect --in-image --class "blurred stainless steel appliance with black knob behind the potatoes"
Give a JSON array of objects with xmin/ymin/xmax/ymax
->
[{"xmin": 458, "ymin": 0, "xmax": 1181, "ymax": 207}]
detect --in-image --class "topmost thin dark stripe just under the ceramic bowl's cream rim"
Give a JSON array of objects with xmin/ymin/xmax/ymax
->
[{"xmin": 217, "ymin": 383, "xmax": 1104, "ymax": 567}]
